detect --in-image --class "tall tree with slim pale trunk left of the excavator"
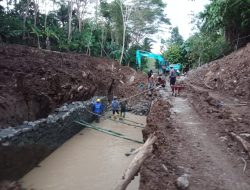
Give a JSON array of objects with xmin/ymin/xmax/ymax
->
[{"xmin": 100, "ymin": 0, "xmax": 169, "ymax": 62}]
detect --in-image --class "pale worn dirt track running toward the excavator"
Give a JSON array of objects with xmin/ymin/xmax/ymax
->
[{"xmin": 172, "ymin": 94, "xmax": 250, "ymax": 190}]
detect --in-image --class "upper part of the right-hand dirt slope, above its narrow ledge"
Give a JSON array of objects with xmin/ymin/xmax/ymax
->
[{"xmin": 188, "ymin": 44, "xmax": 250, "ymax": 101}]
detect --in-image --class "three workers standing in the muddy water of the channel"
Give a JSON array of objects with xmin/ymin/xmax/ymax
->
[{"xmin": 92, "ymin": 96, "xmax": 127, "ymax": 122}]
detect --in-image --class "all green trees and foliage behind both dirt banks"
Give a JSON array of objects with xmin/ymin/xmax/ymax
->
[{"xmin": 0, "ymin": 0, "xmax": 250, "ymax": 69}]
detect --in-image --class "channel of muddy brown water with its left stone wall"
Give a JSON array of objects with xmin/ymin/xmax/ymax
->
[{"xmin": 0, "ymin": 98, "xmax": 146, "ymax": 190}]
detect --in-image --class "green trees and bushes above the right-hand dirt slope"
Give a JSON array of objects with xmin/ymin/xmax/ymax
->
[{"xmin": 162, "ymin": 0, "xmax": 250, "ymax": 70}]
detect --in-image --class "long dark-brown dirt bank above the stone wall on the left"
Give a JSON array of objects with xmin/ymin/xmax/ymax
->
[{"xmin": 0, "ymin": 45, "xmax": 146, "ymax": 128}]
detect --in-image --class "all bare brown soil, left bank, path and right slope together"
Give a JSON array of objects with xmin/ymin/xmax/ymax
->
[{"xmin": 0, "ymin": 44, "xmax": 250, "ymax": 190}]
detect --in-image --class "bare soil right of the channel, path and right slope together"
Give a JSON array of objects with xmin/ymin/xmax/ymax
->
[{"xmin": 140, "ymin": 45, "xmax": 250, "ymax": 190}]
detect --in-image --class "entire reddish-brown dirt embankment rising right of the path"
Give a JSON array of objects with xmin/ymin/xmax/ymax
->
[{"xmin": 186, "ymin": 44, "xmax": 250, "ymax": 149}]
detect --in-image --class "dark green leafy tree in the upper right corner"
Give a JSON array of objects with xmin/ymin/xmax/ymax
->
[{"xmin": 200, "ymin": 0, "xmax": 250, "ymax": 46}]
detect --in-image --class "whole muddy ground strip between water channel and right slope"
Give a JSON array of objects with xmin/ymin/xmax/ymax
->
[{"xmin": 140, "ymin": 85, "xmax": 250, "ymax": 190}]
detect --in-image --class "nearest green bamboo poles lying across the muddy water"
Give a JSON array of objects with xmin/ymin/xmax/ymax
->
[{"xmin": 75, "ymin": 121, "xmax": 143, "ymax": 144}]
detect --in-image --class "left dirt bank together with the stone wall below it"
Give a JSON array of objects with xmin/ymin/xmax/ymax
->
[{"xmin": 0, "ymin": 45, "xmax": 148, "ymax": 189}]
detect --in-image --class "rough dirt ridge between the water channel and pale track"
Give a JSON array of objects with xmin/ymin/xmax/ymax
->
[{"xmin": 139, "ymin": 99, "xmax": 178, "ymax": 190}]
